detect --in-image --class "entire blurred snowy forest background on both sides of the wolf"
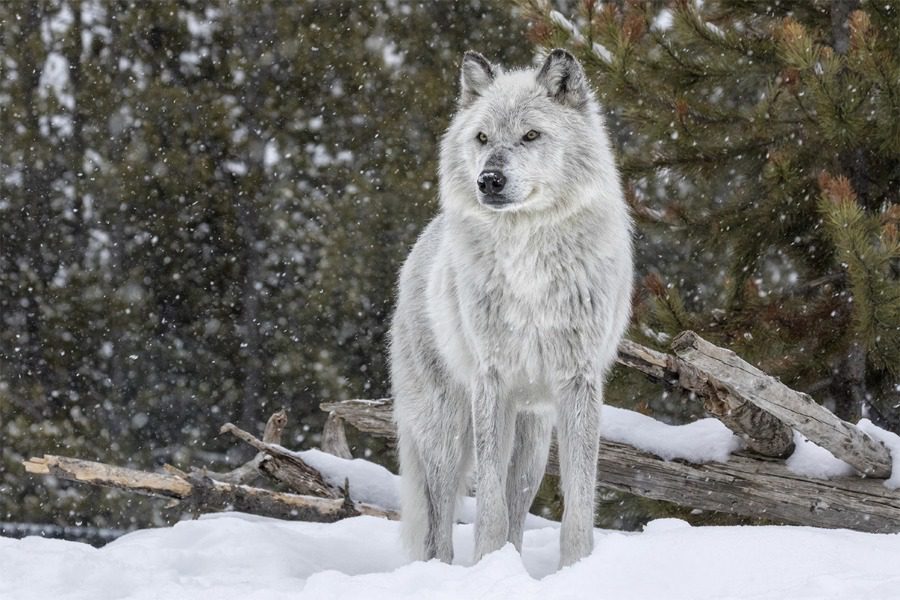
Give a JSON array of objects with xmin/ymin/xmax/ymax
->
[{"xmin": 0, "ymin": 0, "xmax": 900, "ymax": 540}]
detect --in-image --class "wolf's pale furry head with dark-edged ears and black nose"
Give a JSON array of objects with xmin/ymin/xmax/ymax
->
[{"xmin": 441, "ymin": 50, "xmax": 617, "ymax": 216}]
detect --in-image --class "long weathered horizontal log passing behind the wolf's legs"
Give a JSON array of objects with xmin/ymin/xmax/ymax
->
[{"xmin": 322, "ymin": 399, "xmax": 900, "ymax": 532}]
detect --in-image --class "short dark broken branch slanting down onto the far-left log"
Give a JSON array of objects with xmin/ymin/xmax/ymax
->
[{"xmin": 219, "ymin": 423, "xmax": 343, "ymax": 498}]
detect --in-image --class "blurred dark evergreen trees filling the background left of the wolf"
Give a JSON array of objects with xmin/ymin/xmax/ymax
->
[{"xmin": 0, "ymin": 0, "xmax": 528, "ymax": 526}]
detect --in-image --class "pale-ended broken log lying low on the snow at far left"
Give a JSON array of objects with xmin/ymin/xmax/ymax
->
[{"xmin": 24, "ymin": 454, "xmax": 397, "ymax": 523}]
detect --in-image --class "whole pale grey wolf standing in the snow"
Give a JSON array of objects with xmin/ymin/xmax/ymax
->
[{"xmin": 390, "ymin": 49, "xmax": 633, "ymax": 566}]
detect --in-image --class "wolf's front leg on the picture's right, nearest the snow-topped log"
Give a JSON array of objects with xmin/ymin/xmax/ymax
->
[{"xmin": 557, "ymin": 376, "xmax": 603, "ymax": 567}]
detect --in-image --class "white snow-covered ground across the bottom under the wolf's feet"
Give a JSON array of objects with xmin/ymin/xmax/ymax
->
[{"xmin": 0, "ymin": 513, "xmax": 900, "ymax": 600}]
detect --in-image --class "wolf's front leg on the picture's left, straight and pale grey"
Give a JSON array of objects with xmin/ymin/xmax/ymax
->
[{"xmin": 472, "ymin": 372, "xmax": 515, "ymax": 561}]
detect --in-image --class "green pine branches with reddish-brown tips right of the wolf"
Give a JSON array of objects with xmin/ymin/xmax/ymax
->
[{"xmin": 519, "ymin": 0, "xmax": 900, "ymax": 430}]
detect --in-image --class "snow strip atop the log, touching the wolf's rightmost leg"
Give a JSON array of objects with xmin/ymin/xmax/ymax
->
[{"xmin": 601, "ymin": 405, "xmax": 742, "ymax": 463}]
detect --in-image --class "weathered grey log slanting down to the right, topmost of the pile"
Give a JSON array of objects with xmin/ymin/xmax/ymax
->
[{"xmin": 672, "ymin": 331, "xmax": 892, "ymax": 478}]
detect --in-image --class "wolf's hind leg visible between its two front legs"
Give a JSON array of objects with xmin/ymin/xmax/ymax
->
[{"xmin": 506, "ymin": 412, "xmax": 553, "ymax": 552}]
